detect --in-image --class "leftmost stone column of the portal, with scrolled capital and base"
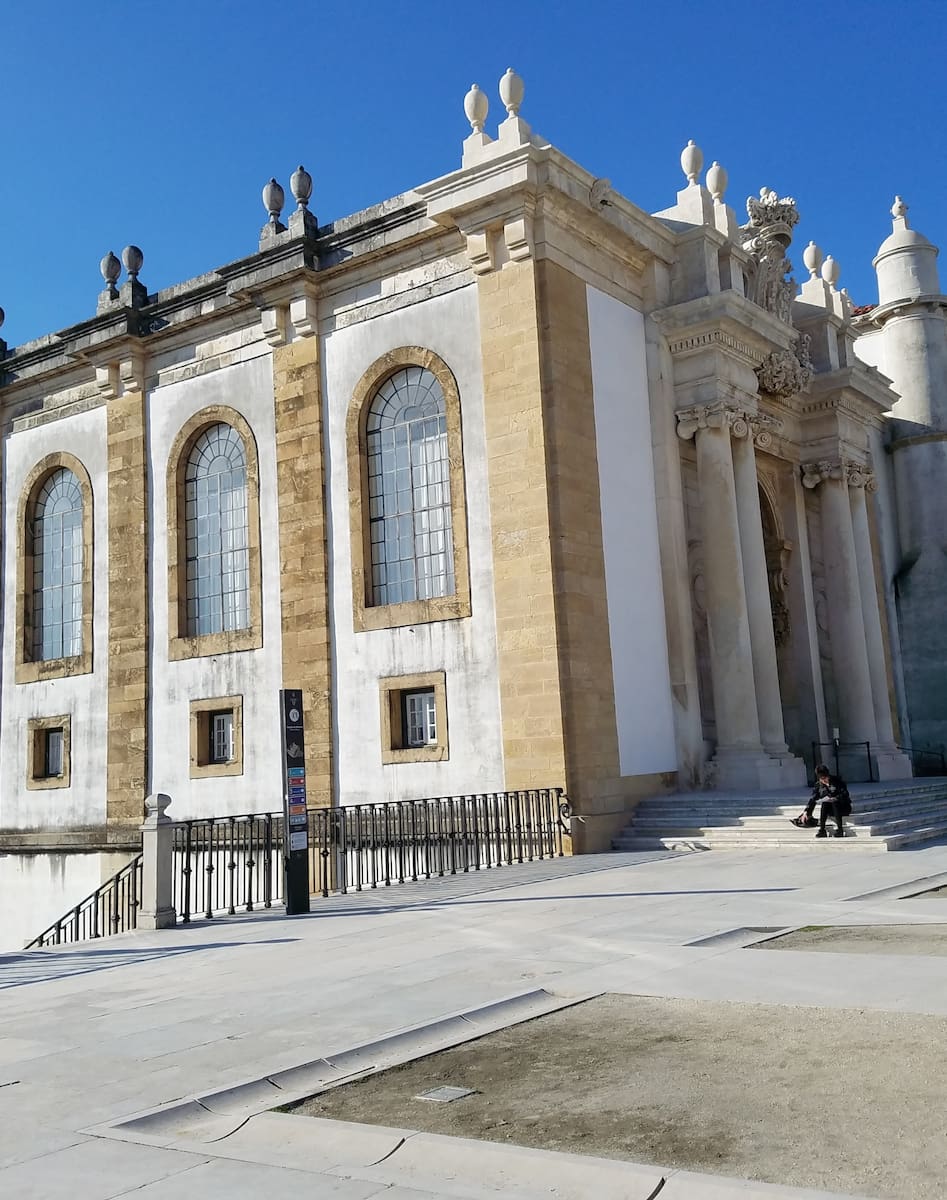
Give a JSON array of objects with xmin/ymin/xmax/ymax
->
[{"xmin": 677, "ymin": 403, "xmax": 779, "ymax": 787}]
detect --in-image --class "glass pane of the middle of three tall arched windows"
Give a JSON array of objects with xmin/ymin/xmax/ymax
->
[{"xmin": 184, "ymin": 425, "xmax": 250, "ymax": 637}]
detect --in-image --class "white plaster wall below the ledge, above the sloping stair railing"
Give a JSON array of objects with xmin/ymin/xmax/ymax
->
[{"xmin": 0, "ymin": 851, "xmax": 131, "ymax": 953}]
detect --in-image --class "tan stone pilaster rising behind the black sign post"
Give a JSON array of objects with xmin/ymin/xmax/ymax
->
[{"xmin": 272, "ymin": 321, "xmax": 334, "ymax": 808}]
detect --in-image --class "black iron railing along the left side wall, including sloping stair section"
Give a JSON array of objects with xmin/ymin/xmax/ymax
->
[{"xmin": 28, "ymin": 787, "xmax": 570, "ymax": 949}]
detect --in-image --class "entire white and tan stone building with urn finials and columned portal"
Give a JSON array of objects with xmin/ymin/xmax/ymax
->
[{"xmin": 0, "ymin": 72, "xmax": 947, "ymax": 848}]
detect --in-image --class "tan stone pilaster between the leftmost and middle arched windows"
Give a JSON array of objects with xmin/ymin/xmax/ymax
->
[{"xmin": 107, "ymin": 374, "xmax": 150, "ymax": 838}]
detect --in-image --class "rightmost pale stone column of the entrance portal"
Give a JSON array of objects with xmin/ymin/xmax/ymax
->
[{"xmin": 849, "ymin": 467, "xmax": 911, "ymax": 779}]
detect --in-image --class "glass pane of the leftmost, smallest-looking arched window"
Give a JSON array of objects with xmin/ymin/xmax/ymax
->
[{"xmin": 31, "ymin": 469, "xmax": 83, "ymax": 662}]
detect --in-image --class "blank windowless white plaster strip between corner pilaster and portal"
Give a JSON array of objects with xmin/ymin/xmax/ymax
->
[{"xmin": 587, "ymin": 287, "xmax": 677, "ymax": 775}]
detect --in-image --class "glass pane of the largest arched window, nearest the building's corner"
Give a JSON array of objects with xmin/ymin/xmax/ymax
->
[{"xmin": 366, "ymin": 367, "xmax": 455, "ymax": 605}]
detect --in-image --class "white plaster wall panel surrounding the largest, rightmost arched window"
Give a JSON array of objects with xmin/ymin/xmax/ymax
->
[{"xmin": 323, "ymin": 284, "xmax": 503, "ymax": 804}]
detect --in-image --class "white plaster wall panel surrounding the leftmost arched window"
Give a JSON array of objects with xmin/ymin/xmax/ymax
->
[{"xmin": 0, "ymin": 408, "xmax": 108, "ymax": 829}]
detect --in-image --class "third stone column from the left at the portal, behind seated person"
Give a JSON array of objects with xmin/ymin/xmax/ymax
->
[{"xmin": 803, "ymin": 462, "xmax": 877, "ymax": 745}]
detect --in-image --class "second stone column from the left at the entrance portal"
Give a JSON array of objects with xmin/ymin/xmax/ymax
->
[{"xmin": 733, "ymin": 420, "xmax": 789, "ymax": 757}]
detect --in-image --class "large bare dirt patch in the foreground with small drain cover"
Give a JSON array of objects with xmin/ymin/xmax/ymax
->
[{"xmin": 293, "ymin": 996, "xmax": 947, "ymax": 1200}]
